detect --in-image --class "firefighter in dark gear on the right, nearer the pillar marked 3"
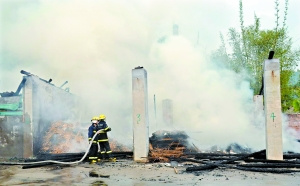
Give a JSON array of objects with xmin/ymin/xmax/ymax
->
[{"xmin": 98, "ymin": 114, "xmax": 116, "ymax": 161}]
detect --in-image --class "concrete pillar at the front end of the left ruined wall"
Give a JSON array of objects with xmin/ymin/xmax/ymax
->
[{"xmin": 23, "ymin": 77, "xmax": 33, "ymax": 158}]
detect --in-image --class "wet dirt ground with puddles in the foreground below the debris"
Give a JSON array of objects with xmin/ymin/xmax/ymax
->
[{"xmin": 0, "ymin": 159, "xmax": 300, "ymax": 186}]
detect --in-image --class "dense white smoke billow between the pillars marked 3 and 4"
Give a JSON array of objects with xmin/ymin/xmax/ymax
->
[{"xmin": 149, "ymin": 36, "xmax": 264, "ymax": 152}]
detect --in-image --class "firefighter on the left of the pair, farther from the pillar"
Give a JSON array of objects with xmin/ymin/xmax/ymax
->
[{"xmin": 88, "ymin": 116, "xmax": 99, "ymax": 164}]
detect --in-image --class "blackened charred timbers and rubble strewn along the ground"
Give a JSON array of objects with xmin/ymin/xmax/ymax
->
[{"xmin": 2, "ymin": 131, "xmax": 300, "ymax": 175}]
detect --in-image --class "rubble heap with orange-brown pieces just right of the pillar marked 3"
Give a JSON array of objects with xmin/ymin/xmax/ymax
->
[{"xmin": 149, "ymin": 131, "xmax": 194, "ymax": 162}]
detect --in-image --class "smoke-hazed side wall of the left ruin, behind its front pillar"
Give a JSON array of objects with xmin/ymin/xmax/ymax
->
[{"xmin": 23, "ymin": 76, "xmax": 80, "ymax": 155}]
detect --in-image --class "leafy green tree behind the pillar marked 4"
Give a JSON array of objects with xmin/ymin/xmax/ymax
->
[{"xmin": 212, "ymin": 0, "xmax": 300, "ymax": 111}]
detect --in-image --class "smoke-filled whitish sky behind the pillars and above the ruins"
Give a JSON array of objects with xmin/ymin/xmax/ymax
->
[{"xmin": 0, "ymin": 0, "xmax": 300, "ymax": 150}]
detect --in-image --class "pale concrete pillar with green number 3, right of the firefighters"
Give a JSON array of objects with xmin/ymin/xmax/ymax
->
[{"xmin": 132, "ymin": 67, "xmax": 149, "ymax": 162}]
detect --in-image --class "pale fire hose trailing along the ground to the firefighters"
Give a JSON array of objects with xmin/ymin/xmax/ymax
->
[{"xmin": 0, "ymin": 129, "xmax": 103, "ymax": 165}]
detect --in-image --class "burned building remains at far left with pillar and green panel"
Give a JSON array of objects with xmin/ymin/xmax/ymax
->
[{"xmin": 0, "ymin": 71, "xmax": 80, "ymax": 158}]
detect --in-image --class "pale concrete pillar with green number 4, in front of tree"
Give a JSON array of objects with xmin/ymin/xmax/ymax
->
[{"xmin": 264, "ymin": 59, "xmax": 283, "ymax": 160}]
